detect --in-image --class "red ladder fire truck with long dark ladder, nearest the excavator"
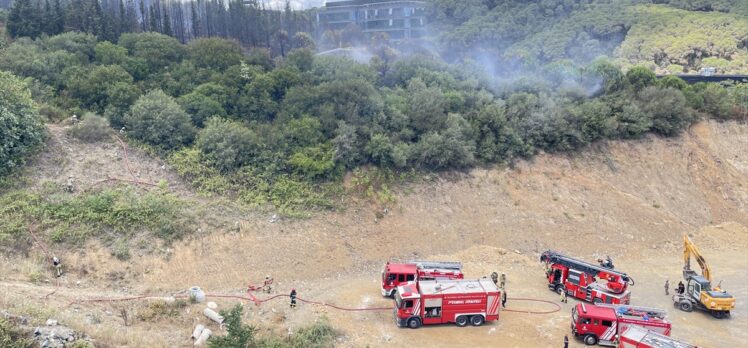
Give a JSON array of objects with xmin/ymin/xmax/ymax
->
[{"xmin": 540, "ymin": 250, "xmax": 634, "ymax": 304}]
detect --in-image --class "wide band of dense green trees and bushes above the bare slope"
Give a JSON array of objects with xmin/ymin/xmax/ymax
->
[{"xmin": 0, "ymin": 27, "xmax": 746, "ymax": 215}]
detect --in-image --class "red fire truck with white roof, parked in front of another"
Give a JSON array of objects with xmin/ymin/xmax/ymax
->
[{"xmin": 395, "ymin": 279, "xmax": 501, "ymax": 329}]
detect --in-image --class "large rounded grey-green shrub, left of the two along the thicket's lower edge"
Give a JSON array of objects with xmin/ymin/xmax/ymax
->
[{"xmin": 124, "ymin": 90, "xmax": 196, "ymax": 150}]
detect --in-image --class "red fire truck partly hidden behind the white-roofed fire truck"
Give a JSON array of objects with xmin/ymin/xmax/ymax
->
[{"xmin": 382, "ymin": 261, "xmax": 464, "ymax": 297}]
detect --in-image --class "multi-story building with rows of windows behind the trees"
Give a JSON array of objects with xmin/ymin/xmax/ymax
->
[{"xmin": 317, "ymin": 0, "xmax": 427, "ymax": 40}]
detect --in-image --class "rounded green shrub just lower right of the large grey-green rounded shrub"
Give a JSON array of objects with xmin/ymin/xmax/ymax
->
[{"xmin": 197, "ymin": 117, "xmax": 261, "ymax": 171}]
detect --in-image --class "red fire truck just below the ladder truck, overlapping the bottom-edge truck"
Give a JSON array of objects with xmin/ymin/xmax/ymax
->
[{"xmin": 571, "ymin": 303, "xmax": 672, "ymax": 346}]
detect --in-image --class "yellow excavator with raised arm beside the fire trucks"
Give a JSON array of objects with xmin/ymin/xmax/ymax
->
[{"xmin": 673, "ymin": 235, "xmax": 735, "ymax": 319}]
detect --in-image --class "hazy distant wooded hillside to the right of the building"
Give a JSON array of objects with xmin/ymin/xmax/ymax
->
[{"xmin": 426, "ymin": 0, "xmax": 748, "ymax": 73}]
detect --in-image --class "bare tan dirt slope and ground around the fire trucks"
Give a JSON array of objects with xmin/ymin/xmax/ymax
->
[{"xmin": 0, "ymin": 122, "xmax": 748, "ymax": 347}]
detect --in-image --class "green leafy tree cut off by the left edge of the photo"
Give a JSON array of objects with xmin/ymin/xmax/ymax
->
[{"xmin": 0, "ymin": 71, "xmax": 44, "ymax": 176}]
